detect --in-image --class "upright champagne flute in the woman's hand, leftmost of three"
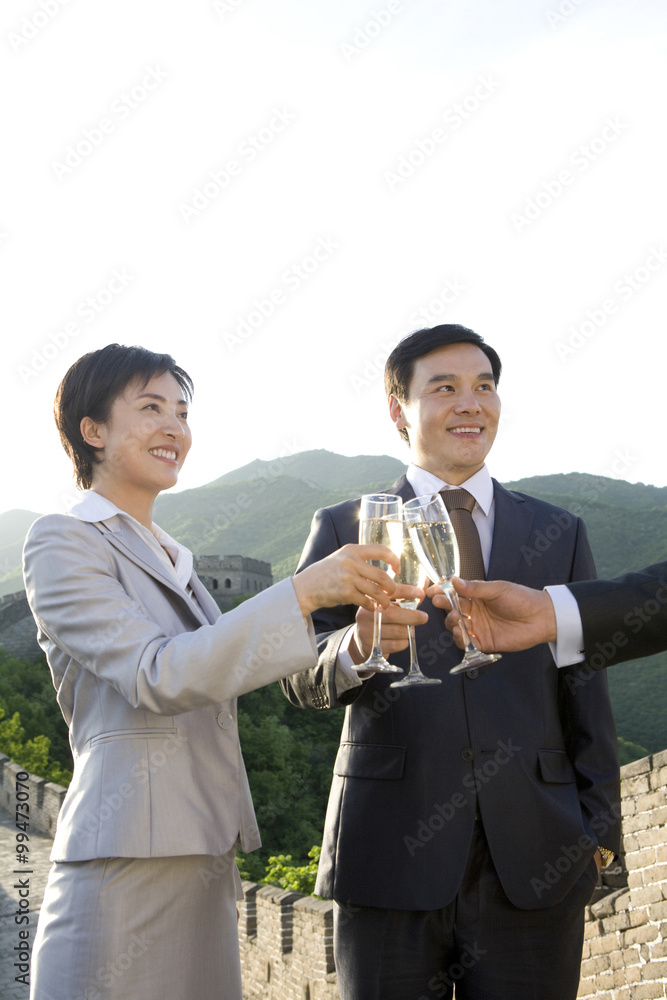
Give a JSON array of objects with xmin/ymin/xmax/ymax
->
[{"xmin": 352, "ymin": 493, "xmax": 403, "ymax": 674}]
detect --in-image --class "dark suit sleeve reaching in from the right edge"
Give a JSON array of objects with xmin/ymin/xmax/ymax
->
[{"xmin": 569, "ymin": 562, "xmax": 667, "ymax": 670}]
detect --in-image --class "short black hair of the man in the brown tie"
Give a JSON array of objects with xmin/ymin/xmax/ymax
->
[{"xmin": 384, "ymin": 323, "xmax": 502, "ymax": 441}]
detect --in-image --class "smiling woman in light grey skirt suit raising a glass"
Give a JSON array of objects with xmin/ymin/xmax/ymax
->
[{"xmin": 24, "ymin": 344, "xmax": 410, "ymax": 1000}]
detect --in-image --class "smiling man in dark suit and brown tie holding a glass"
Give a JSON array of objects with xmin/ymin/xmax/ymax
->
[{"xmin": 282, "ymin": 326, "xmax": 620, "ymax": 1000}]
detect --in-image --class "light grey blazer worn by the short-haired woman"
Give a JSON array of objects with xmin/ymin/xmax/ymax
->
[{"xmin": 24, "ymin": 514, "xmax": 317, "ymax": 861}]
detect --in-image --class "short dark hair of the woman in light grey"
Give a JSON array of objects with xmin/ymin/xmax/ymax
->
[{"xmin": 53, "ymin": 344, "xmax": 194, "ymax": 489}]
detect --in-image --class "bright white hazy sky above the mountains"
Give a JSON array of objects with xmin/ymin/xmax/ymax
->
[{"xmin": 0, "ymin": 0, "xmax": 667, "ymax": 512}]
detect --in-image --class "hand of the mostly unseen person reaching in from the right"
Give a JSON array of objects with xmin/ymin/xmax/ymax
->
[{"xmin": 427, "ymin": 577, "xmax": 556, "ymax": 653}]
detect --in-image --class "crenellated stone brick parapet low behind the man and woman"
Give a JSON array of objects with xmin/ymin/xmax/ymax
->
[{"xmin": 0, "ymin": 751, "xmax": 667, "ymax": 1000}]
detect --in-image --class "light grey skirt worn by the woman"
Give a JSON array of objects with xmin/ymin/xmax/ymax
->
[{"xmin": 30, "ymin": 851, "xmax": 243, "ymax": 1000}]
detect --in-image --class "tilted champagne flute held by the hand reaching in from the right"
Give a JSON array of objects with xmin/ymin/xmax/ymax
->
[{"xmin": 403, "ymin": 493, "xmax": 500, "ymax": 674}]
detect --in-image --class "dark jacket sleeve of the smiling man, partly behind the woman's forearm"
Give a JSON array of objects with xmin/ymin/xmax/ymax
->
[{"xmin": 280, "ymin": 502, "xmax": 361, "ymax": 709}]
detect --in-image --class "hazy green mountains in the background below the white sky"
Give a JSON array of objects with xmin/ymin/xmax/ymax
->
[{"xmin": 0, "ymin": 450, "xmax": 667, "ymax": 756}]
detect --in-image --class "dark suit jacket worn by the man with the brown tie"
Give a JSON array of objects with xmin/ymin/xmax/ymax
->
[{"xmin": 281, "ymin": 476, "xmax": 620, "ymax": 910}]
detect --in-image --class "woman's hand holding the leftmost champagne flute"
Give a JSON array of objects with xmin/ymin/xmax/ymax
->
[{"xmin": 292, "ymin": 545, "xmax": 422, "ymax": 616}]
